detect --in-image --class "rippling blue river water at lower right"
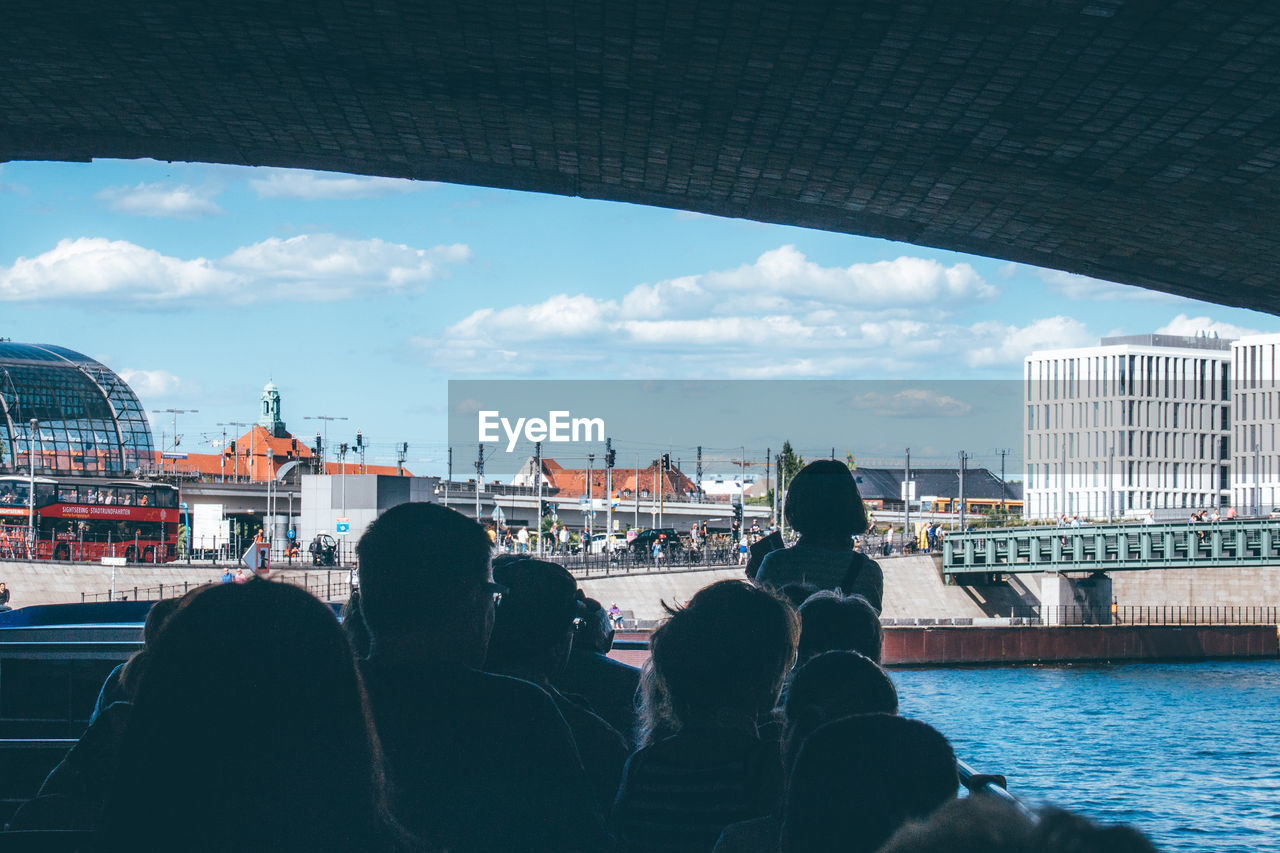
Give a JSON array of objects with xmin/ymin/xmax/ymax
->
[{"xmin": 892, "ymin": 661, "xmax": 1280, "ymax": 853}]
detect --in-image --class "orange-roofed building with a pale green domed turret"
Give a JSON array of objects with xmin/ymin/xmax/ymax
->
[{"xmin": 155, "ymin": 382, "xmax": 411, "ymax": 483}]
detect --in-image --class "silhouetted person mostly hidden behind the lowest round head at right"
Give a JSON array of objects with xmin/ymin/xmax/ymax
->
[{"xmin": 716, "ymin": 652, "xmax": 897, "ymax": 853}]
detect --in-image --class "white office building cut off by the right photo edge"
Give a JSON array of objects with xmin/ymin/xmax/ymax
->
[{"xmin": 1231, "ymin": 334, "xmax": 1280, "ymax": 515}]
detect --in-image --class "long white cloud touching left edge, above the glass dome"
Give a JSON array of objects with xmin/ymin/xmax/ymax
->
[{"xmin": 0, "ymin": 234, "xmax": 471, "ymax": 307}]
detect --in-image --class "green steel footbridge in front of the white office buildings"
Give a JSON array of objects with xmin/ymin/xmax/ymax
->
[{"xmin": 942, "ymin": 519, "xmax": 1280, "ymax": 579}]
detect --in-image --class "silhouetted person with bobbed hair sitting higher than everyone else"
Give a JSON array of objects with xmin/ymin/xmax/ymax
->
[{"xmin": 755, "ymin": 460, "xmax": 884, "ymax": 612}]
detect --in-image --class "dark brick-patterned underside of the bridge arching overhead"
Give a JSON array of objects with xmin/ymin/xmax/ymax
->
[{"xmin": 0, "ymin": 0, "xmax": 1280, "ymax": 311}]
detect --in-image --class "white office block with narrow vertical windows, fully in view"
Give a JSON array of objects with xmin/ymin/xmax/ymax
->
[{"xmin": 1023, "ymin": 334, "xmax": 1233, "ymax": 519}]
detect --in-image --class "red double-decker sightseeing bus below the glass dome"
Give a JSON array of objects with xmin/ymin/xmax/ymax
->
[{"xmin": 0, "ymin": 476, "xmax": 180, "ymax": 562}]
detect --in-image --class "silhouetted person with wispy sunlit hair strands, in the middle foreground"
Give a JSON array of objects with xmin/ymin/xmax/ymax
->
[{"xmin": 613, "ymin": 580, "xmax": 799, "ymax": 853}]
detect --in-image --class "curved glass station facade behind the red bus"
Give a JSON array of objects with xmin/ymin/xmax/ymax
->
[{"xmin": 0, "ymin": 341, "xmax": 152, "ymax": 476}]
